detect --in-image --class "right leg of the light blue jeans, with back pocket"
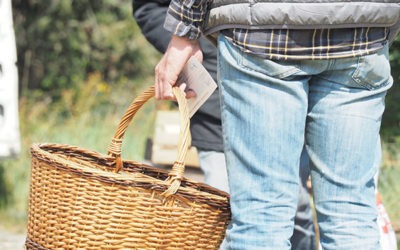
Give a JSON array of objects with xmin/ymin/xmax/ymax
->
[{"xmin": 306, "ymin": 48, "xmax": 392, "ymax": 250}]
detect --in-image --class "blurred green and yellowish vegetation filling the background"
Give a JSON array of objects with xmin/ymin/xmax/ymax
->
[{"xmin": 0, "ymin": 0, "xmax": 400, "ymax": 244}]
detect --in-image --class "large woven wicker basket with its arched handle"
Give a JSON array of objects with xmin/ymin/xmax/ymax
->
[{"xmin": 25, "ymin": 87, "xmax": 230, "ymax": 249}]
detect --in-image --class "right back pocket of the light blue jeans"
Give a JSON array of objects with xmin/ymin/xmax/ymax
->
[{"xmin": 352, "ymin": 47, "xmax": 391, "ymax": 90}]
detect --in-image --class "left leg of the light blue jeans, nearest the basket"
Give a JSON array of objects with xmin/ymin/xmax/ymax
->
[{"xmin": 218, "ymin": 36, "xmax": 307, "ymax": 250}]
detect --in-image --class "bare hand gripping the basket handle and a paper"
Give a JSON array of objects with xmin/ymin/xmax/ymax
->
[{"xmin": 155, "ymin": 36, "xmax": 203, "ymax": 100}]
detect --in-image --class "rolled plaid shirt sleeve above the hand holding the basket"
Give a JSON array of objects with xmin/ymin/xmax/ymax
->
[{"xmin": 164, "ymin": 0, "xmax": 211, "ymax": 40}]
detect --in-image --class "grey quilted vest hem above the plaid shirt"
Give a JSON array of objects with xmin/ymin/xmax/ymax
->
[{"xmin": 203, "ymin": 0, "xmax": 400, "ymax": 41}]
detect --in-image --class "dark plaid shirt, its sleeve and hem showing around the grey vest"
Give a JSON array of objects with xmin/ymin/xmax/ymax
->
[{"xmin": 165, "ymin": 0, "xmax": 389, "ymax": 60}]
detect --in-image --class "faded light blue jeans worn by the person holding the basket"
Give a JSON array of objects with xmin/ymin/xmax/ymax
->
[{"xmin": 218, "ymin": 35, "xmax": 393, "ymax": 250}]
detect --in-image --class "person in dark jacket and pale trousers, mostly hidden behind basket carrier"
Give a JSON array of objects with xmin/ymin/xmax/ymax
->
[{"xmin": 132, "ymin": 0, "xmax": 225, "ymax": 192}]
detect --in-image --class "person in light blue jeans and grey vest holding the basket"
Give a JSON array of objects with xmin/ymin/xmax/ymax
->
[{"xmin": 155, "ymin": 0, "xmax": 400, "ymax": 250}]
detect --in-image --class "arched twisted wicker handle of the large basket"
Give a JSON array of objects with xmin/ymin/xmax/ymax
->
[{"xmin": 108, "ymin": 86, "xmax": 191, "ymax": 196}]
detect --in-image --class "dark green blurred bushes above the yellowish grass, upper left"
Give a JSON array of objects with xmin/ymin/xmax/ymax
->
[{"xmin": 12, "ymin": 0, "xmax": 154, "ymax": 98}]
